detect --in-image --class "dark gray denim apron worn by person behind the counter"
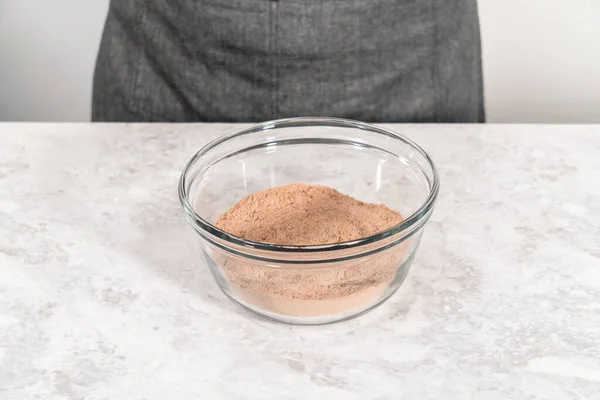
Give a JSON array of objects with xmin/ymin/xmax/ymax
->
[{"xmin": 92, "ymin": 0, "xmax": 485, "ymax": 122}]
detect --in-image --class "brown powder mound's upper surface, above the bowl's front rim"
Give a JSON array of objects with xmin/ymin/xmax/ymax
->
[{"xmin": 215, "ymin": 183, "xmax": 402, "ymax": 245}]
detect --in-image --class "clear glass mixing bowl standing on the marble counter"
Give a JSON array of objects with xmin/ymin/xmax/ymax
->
[{"xmin": 179, "ymin": 118, "xmax": 439, "ymax": 324}]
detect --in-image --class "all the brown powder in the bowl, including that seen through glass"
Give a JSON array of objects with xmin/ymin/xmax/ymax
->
[{"xmin": 215, "ymin": 183, "xmax": 405, "ymax": 316}]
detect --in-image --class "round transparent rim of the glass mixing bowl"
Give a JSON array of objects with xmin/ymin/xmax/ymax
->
[{"xmin": 178, "ymin": 117, "xmax": 440, "ymax": 252}]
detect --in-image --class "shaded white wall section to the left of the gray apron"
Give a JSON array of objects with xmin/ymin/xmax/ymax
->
[{"xmin": 0, "ymin": 0, "xmax": 108, "ymax": 121}]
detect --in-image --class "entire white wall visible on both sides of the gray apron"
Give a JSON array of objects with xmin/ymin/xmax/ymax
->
[{"xmin": 0, "ymin": 0, "xmax": 600, "ymax": 123}]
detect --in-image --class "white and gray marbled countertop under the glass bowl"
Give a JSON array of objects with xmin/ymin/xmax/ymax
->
[{"xmin": 0, "ymin": 124, "xmax": 600, "ymax": 400}]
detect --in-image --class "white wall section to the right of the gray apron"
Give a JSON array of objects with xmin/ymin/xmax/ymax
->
[{"xmin": 479, "ymin": 0, "xmax": 600, "ymax": 123}]
